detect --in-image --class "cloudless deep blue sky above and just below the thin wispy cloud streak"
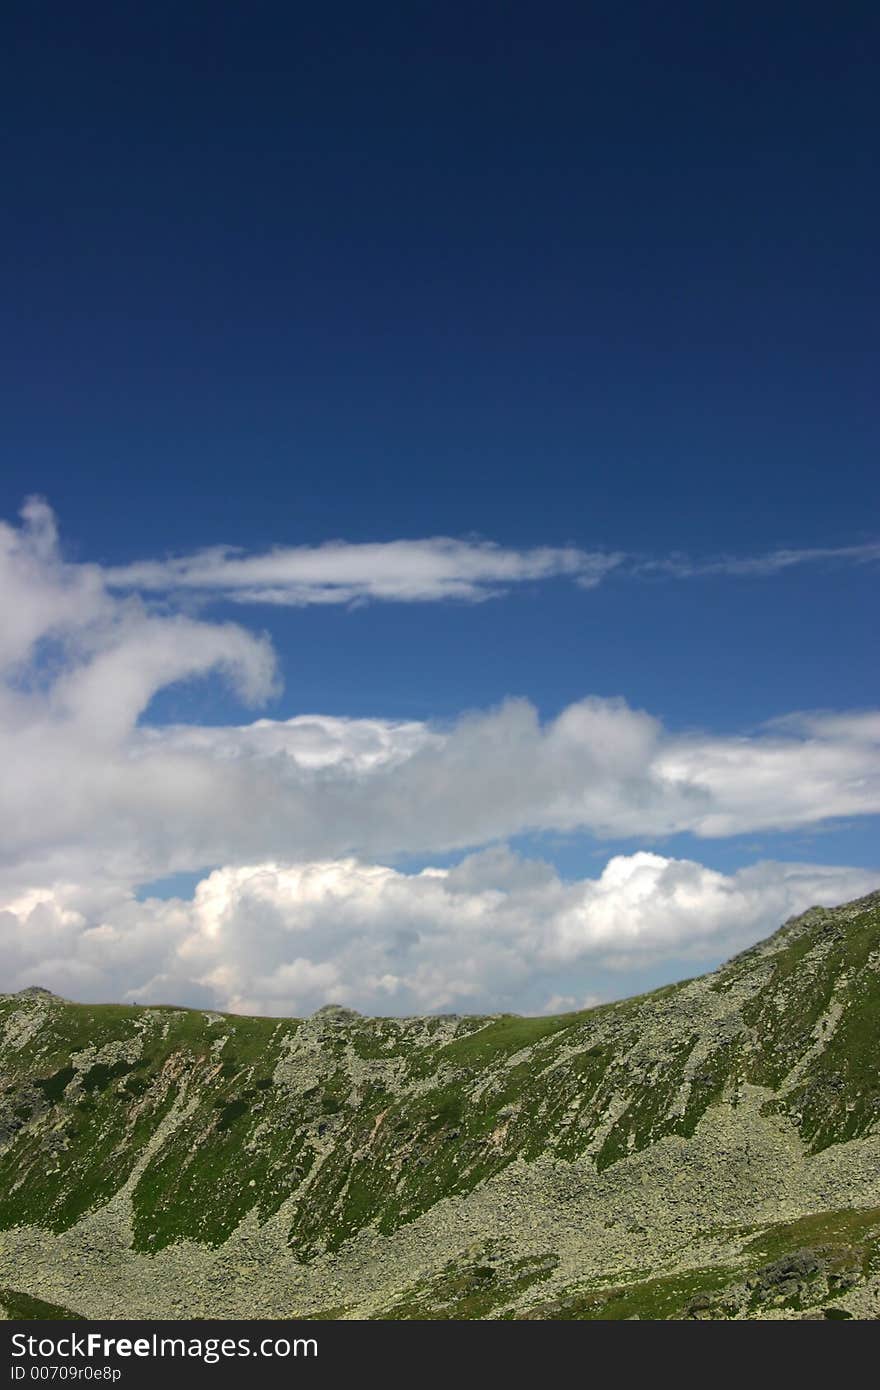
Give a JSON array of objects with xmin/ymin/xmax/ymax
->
[{"xmin": 0, "ymin": 0, "xmax": 880, "ymax": 856}]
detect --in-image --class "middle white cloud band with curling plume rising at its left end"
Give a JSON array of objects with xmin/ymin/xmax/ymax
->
[{"xmin": 0, "ymin": 502, "xmax": 880, "ymax": 891}]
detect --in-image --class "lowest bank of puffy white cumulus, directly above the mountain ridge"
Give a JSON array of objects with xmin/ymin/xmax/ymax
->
[{"xmin": 0, "ymin": 848, "xmax": 876, "ymax": 1013}]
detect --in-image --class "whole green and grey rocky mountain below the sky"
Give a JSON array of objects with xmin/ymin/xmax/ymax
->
[{"xmin": 0, "ymin": 894, "xmax": 880, "ymax": 1319}]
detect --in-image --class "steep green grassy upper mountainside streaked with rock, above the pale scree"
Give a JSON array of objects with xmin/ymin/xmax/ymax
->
[{"xmin": 0, "ymin": 894, "xmax": 880, "ymax": 1307}]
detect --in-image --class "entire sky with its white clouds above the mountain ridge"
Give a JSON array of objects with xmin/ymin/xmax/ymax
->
[{"xmin": 0, "ymin": 0, "xmax": 880, "ymax": 1015}]
